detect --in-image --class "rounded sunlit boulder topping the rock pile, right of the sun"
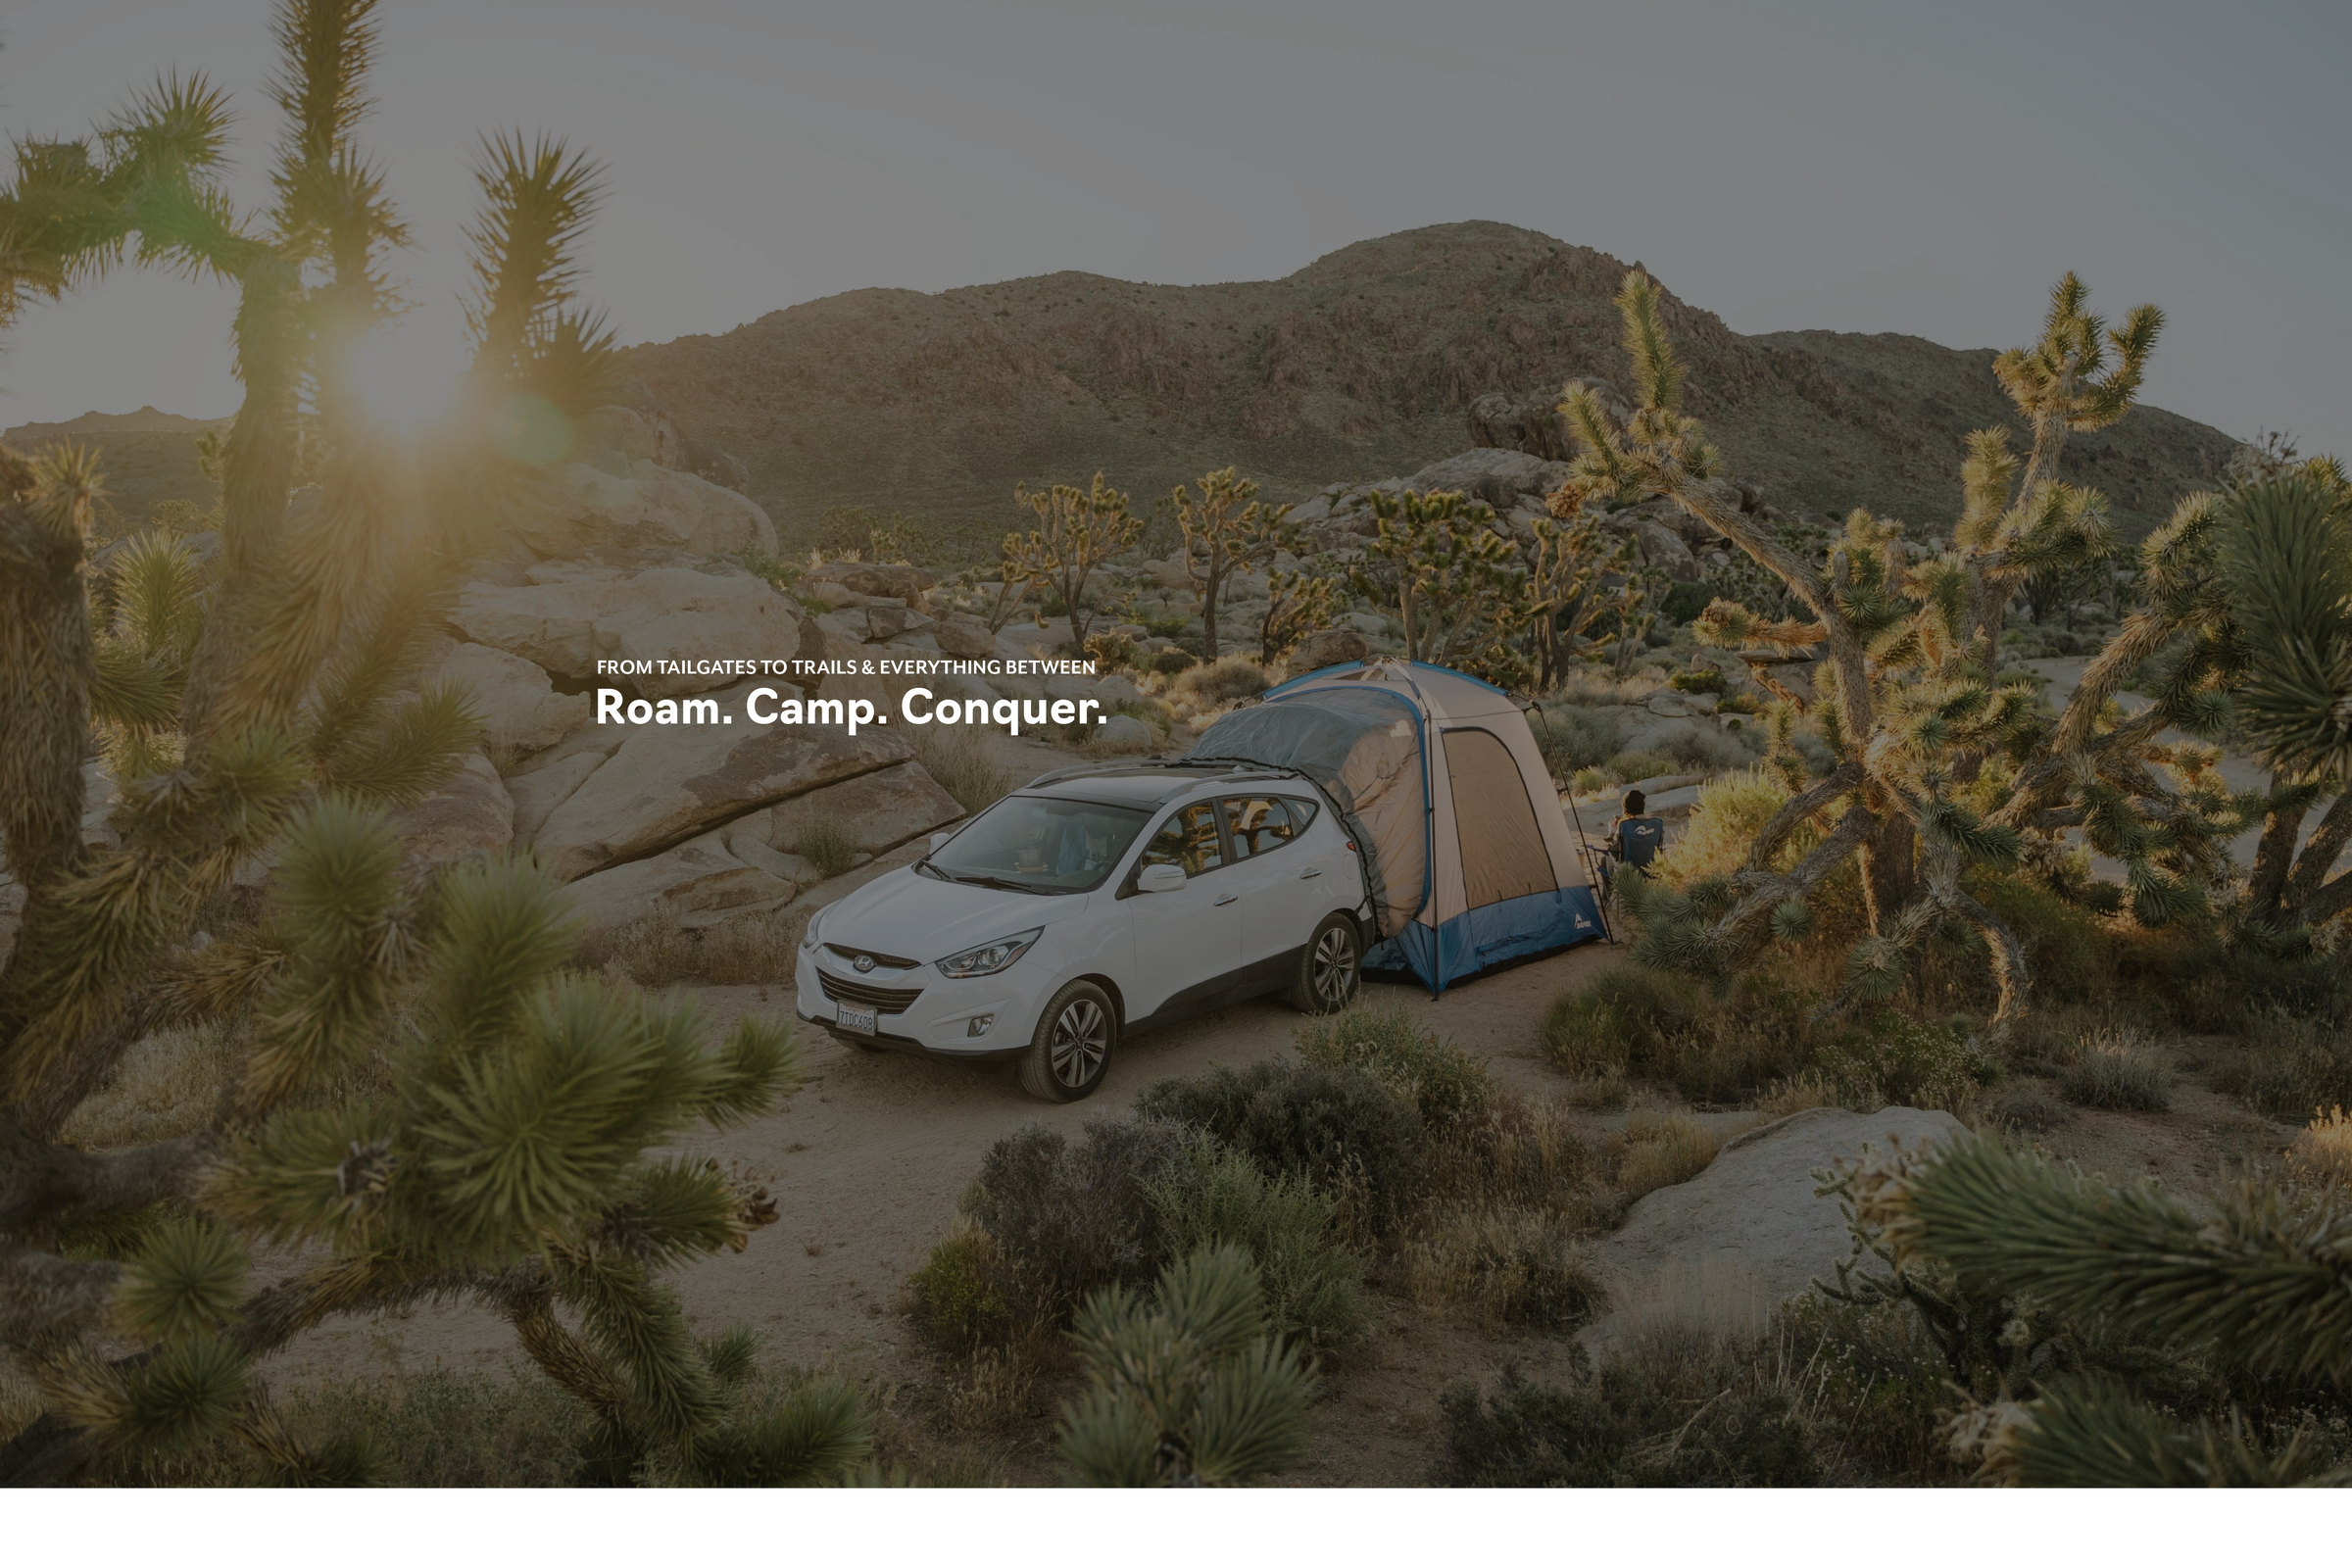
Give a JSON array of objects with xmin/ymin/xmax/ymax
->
[{"xmin": 515, "ymin": 461, "xmax": 776, "ymax": 558}]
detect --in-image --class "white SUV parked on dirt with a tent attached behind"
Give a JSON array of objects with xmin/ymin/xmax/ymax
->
[{"xmin": 793, "ymin": 761, "xmax": 1369, "ymax": 1101}]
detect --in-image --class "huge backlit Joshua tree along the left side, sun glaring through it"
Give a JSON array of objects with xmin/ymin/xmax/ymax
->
[{"xmin": 0, "ymin": 0, "xmax": 847, "ymax": 1479}]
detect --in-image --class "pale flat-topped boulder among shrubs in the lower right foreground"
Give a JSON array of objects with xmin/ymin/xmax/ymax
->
[{"xmin": 1586, "ymin": 1104, "xmax": 1966, "ymax": 1349}]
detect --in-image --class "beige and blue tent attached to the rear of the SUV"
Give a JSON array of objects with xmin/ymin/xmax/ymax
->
[{"xmin": 1188, "ymin": 659, "xmax": 1601, "ymax": 995}]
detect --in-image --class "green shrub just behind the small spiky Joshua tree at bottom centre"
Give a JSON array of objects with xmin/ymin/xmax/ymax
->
[{"xmin": 1148, "ymin": 1150, "xmax": 1371, "ymax": 1349}]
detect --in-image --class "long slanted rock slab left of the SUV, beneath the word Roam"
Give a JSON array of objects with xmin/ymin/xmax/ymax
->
[{"xmin": 531, "ymin": 682, "xmax": 915, "ymax": 882}]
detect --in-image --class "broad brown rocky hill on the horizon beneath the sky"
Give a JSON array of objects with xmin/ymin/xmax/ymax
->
[{"xmin": 628, "ymin": 223, "xmax": 2234, "ymax": 552}]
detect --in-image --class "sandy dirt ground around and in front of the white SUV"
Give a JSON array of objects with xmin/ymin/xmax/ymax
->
[{"xmin": 257, "ymin": 945, "xmax": 1616, "ymax": 1380}]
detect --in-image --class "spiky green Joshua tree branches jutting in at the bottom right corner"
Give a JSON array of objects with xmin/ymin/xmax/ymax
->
[{"xmin": 1841, "ymin": 1138, "xmax": 2352, "ymax": 1486}]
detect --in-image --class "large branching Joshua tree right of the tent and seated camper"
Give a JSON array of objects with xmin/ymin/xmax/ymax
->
[{"xmin": 1562, "ymin": 272, "xmax": 2244, "ymax": 1027}]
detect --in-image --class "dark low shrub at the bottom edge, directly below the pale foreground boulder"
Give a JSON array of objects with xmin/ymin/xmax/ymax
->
[{"xmin": 1430, "ymin": 1331, "xmax": 1821, "ymax": 1486}]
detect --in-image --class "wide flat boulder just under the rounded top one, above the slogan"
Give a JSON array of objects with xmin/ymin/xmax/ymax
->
[{"xmin": 449, "ymin": 562, "xmax": 807, "ymax": 698}]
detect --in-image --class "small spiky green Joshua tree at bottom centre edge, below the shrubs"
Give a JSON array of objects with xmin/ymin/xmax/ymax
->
[{"xmin": 1060, "ymin": 1246, "xmax": 1315, "ymax": 1486}]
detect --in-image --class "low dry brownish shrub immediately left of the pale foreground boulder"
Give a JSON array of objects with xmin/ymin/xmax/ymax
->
[{"xmin": 1399, "ymin": 1203, "xmax": 1604, "ymax": 1328}]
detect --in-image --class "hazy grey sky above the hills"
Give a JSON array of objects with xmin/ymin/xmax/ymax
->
[{"xmin": 0, "ymin": 0, "xmax": 2352, "ymax": 452}]
